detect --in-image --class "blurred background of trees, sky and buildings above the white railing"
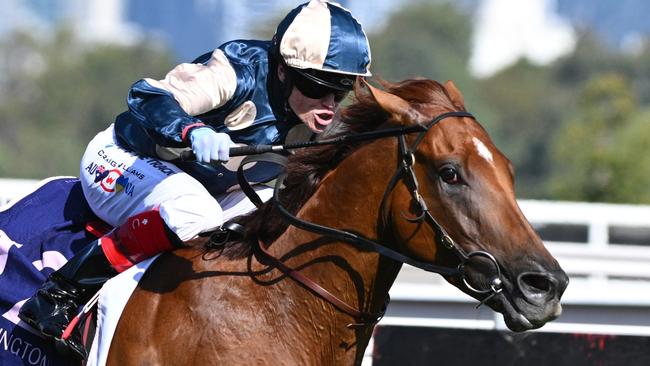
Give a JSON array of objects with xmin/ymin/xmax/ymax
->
[{"xmin": 0, "ymin": 0, "xmax": 650, "ymax": 203}]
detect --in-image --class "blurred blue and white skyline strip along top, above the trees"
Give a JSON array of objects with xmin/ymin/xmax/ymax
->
[{"xmin": 0, "ymin": 0, "xmax": 650, "ymax": 70}]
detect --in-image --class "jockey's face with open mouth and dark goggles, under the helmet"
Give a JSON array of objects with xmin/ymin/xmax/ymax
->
[{"xmin": 278, "ymin": 67, "xmax": 347, "ymax": 133}]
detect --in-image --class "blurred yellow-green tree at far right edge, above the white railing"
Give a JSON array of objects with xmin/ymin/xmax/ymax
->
[{"xmin": 549, "ymin": 73, "xmax": 650, "ymax": 203}]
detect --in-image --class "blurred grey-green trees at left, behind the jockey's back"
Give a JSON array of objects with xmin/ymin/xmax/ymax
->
[{"xmin": 0, "ymin": 28, "xmax": 173, "ymax": 178}]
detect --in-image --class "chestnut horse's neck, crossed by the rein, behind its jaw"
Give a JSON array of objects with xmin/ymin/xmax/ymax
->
[{"xmin": 271, "ymin": 140, "xmax": 401, "ymax": 326}]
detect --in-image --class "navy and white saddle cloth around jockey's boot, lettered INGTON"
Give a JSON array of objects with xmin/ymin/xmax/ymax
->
[{"xmin": 0, "ymin": 177, "xmax": 155, "ymax": 366}]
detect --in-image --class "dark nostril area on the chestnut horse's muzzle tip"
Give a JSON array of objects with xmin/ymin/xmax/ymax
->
[{"xmin": 517, "ymin": 270, "xmax": 569, "ymax": 306}]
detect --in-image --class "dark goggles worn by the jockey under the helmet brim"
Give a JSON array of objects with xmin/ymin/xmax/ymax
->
[{"xmin": 291, "ymin": 69, "xmax": 354, "ymax": 102}]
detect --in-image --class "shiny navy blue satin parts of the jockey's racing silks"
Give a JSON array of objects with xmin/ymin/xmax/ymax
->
[{"xmin": 115, "ymin": 40, "xmax": 292, "ymax": 195}]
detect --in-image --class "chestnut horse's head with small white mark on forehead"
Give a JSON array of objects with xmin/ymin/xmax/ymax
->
[{"xmin": 368, "ymin": 80, "xmax": 568, "ymax": 331}]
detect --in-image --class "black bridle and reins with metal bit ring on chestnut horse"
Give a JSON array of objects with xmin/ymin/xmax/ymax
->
[{"xmin": 251, "ymin": 111, "xmax": 503, "ymax": 327}]
